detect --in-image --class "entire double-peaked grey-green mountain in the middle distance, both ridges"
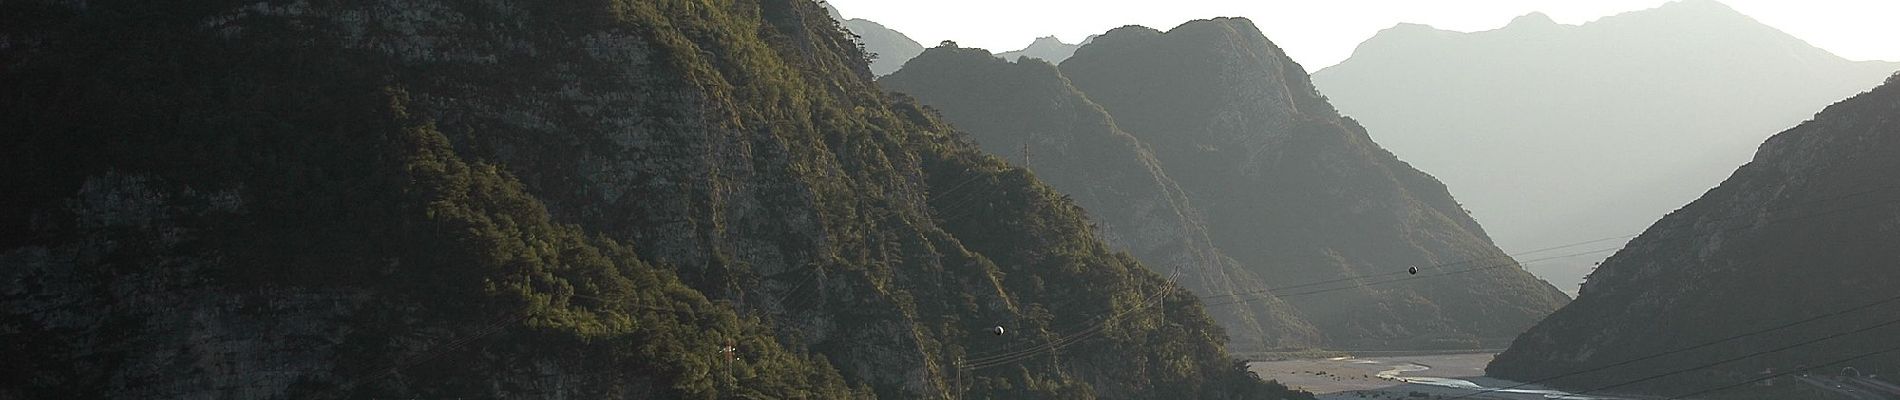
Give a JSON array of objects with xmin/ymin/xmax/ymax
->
[{"xmin": 882, "ymin": 19, "xmax": 1568, "ymax": 349}]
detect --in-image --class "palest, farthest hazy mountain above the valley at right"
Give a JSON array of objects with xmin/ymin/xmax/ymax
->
[{"xmin": 1313, "ymin": 0, "xmax": 1900, "ymax": 290}]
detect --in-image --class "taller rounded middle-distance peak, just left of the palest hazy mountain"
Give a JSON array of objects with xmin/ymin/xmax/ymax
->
[{"xmin": 1060, "ymin": 19, "xmax": 1568, "ymax": 349}]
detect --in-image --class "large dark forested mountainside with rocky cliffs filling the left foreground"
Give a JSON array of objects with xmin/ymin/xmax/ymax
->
[{"xmin": 0, "ymin": 0, "xmax": 1311, "ymax": 398}]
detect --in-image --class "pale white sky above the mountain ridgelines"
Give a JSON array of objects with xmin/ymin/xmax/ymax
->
[{"xmin": 828, "ymin": 0, "xmax": 1900, "ymax": 70}]
